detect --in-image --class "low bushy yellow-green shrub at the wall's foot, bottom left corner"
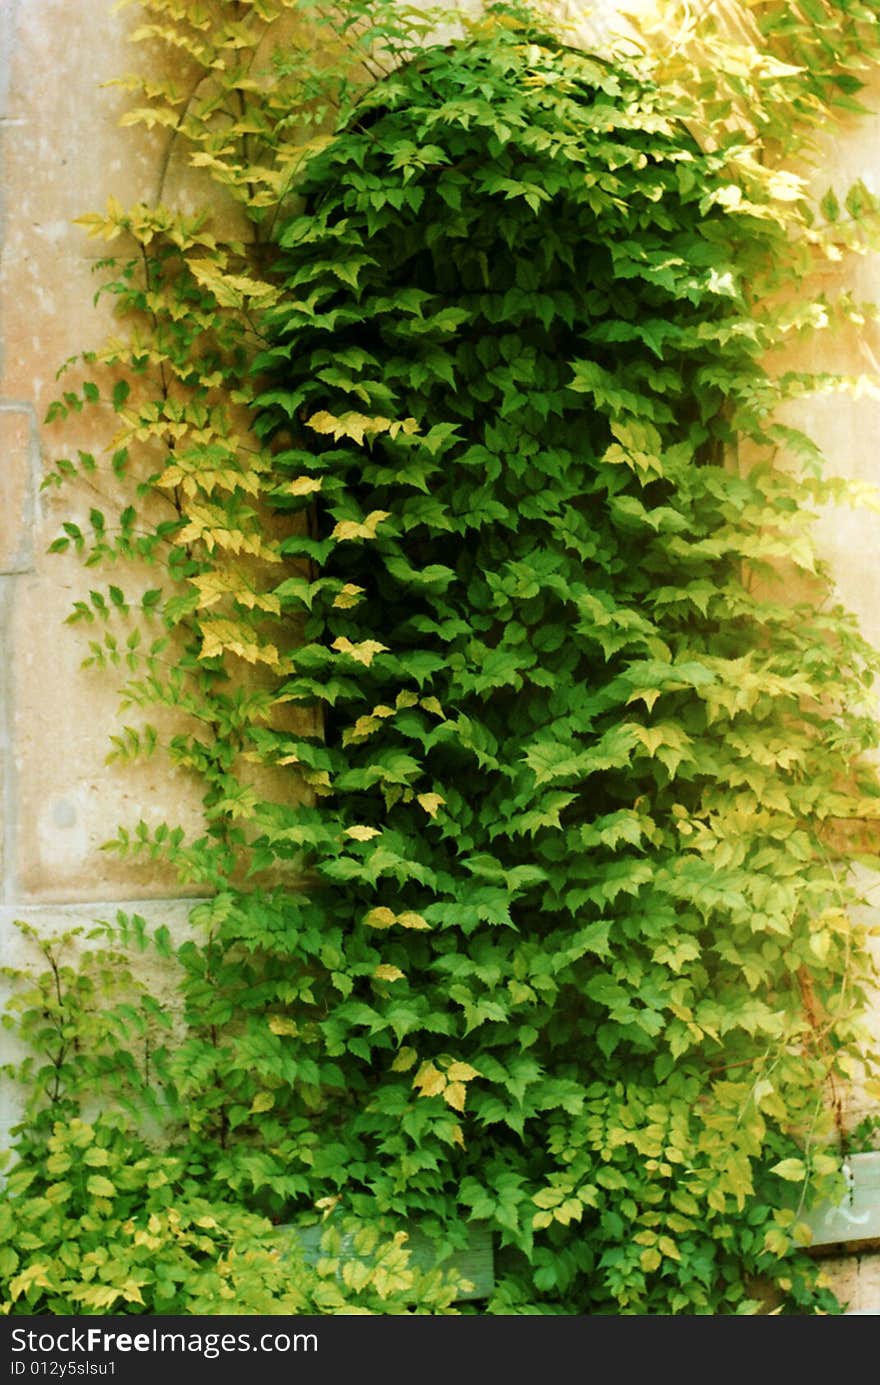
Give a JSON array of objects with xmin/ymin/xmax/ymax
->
[{"xmin": 0, "ymin": 1115, "xmax": 315, "ymax": 1314}]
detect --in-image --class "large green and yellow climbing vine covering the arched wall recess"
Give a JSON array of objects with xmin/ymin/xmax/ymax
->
[{"xmin": 7, "ymin": 0, "xmax": 880, "ymax": 1314}]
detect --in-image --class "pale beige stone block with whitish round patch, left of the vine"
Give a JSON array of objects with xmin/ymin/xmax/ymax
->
[{"xmin": 11, "ymin": 557, "xmax": 204, "ymax": 900}]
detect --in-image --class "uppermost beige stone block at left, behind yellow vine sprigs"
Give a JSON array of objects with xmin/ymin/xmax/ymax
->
[{"xmin": 0, "ymin": 0, "xmax": 244, "ymax": 420}]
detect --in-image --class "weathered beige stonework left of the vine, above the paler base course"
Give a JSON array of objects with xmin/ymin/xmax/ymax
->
[{"xmin": 0, "ymin": 0, "xmax": 250, "ymax": 900}]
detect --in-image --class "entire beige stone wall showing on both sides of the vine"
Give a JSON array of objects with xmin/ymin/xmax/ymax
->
[{"xmin": 0, "ymin": 0, "xmax": 880, "ymax": 1312}]
